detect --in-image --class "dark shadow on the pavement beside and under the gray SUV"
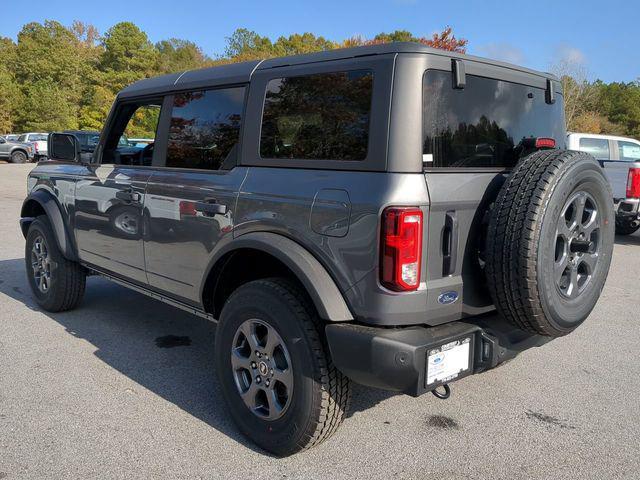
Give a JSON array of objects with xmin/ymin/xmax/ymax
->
[{"xmin": 0, "ymin": 259, "xmax": 394, "ymax": 454}]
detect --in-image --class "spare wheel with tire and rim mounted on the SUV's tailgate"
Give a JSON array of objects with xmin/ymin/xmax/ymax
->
[{"xmin": 485, "ymin": 150, "xmax": 615, "ymax": 337}]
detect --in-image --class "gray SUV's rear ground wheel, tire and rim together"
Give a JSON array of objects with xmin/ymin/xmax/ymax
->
[{"xmin": 215, "ymin": 279, "xmax": 350, "ymax": 456}]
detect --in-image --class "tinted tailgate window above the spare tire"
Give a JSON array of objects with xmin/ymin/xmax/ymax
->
[{"xmin": 422, "ymin": 70, "xmax": 565, "ymax": 167}]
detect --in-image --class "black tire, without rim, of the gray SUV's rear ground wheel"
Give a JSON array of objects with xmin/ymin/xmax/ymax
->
[{"xmin": 215, "ymin": 278, "xmax": 351, "ymax": 456}]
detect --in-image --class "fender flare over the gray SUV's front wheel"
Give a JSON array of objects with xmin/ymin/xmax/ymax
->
[{"xmin": 20, "ymin": 190, "xmax": 78, "ymax": 262}]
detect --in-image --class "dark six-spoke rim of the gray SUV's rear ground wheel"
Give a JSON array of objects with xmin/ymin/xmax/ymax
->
[{"xmin": 231, "ymin": 319, "xmax": 293, "ymax": 421}]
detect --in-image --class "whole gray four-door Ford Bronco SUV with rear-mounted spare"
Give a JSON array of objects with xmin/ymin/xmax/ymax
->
[{"xmin": 21, "ymin": 43, "xmax": 615, "ymax": 455}]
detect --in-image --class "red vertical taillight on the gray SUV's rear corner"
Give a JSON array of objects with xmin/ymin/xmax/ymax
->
[{"xmin": 380, "ymin": 207, "xmax": 422, "ymax": 291}]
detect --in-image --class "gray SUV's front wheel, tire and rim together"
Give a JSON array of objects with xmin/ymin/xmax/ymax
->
[{"xmin": 24, "ymin": 216, "xmax": 86, "ymax": 312}]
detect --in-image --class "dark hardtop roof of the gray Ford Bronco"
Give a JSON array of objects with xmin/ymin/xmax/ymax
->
[{"xmin": 119, "ymin": 42, "xmax": 557, "ymax": 98}]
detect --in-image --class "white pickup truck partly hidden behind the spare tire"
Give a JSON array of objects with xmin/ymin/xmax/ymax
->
[{"xmin": 567, "ymin": 133, "xmax": 640, "ymax": 235}]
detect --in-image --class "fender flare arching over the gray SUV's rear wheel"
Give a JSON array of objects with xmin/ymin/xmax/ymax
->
[{"xmin": 200, "ymin": 232, "xmax": 353, "ymax": 322}]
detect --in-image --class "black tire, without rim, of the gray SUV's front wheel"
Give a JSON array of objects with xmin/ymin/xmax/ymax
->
[{"xmin": 24, "ymin": 215, "xmax": 86, "ymax": 312}]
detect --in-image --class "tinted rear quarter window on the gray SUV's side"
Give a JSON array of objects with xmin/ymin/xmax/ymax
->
[{"xmin": 260, "ymin": 70, "xmax": 373, "ymax": 160}]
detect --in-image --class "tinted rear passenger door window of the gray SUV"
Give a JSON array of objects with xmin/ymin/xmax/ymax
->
[{"xmin": 167, "ymin": 87, "xmax": 245, "ymax": 170}]
